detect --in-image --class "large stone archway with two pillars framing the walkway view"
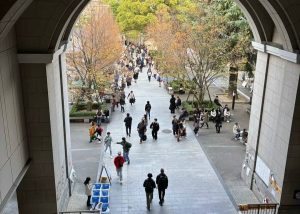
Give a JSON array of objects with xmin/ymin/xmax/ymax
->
[{"xmin": 0, "ymin": 0, "xmax": 300, "ymax": 213}]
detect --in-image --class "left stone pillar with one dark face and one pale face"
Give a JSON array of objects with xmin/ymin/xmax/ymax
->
[{"xmin": 17, "ymin": 44, "xmax": 71, "ymax": 214}]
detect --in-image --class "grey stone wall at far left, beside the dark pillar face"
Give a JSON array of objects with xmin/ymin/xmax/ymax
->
[{"xmin": 0, "ymin": 27, "xmax": 28, "ymax": 209}]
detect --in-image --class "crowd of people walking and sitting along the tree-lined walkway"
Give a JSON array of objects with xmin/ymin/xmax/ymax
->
[{"xmin": 85, "ymin": 42, "xmax": 248, "ymax": 210}]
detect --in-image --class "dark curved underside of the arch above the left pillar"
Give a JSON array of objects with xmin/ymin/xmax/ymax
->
[{"xmin": 16, "ymin": 0, "xmax": 86, "ymax": 53}]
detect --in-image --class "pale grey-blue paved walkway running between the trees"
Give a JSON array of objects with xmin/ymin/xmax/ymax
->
[{"xmin": 104, "ymin": 71, "xmax": 236, "ymax": 214}]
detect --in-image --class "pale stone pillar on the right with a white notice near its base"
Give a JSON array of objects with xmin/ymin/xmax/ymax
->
[{"xmin": 242, "ymin": 40, "xmax": 300, "ymax": 214}]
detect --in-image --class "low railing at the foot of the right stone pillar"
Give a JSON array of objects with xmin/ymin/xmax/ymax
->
[{"xmin": 239, "ymin": 204, "xmax": 277, "ymax": 214}]
